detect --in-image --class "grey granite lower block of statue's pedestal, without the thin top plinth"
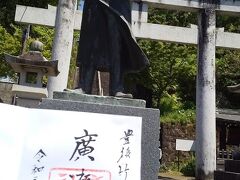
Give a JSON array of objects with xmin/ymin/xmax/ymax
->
[{"xmin": 39, "ymin": 99, "xmax": 160, "ymax": 180}]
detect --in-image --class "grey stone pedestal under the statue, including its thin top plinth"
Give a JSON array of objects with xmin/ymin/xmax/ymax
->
[{"xmin": 39, "ymin": 92, "xmax": 160, "ymax": 180}]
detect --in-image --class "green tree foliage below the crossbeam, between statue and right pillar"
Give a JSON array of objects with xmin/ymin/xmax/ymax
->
[{"xmin": 135, "ymin": 40, "xmax": 197, "ymax": 108}]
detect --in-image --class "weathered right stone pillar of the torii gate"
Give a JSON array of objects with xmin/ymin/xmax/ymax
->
[{"xmin": 196, "ymin": 2, "xmax": 216, "ymax": 180}]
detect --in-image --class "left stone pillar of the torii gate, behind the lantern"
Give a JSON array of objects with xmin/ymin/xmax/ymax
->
[{"xmin": 47, "ymin": 0, "xmax": 76, "ymax": 98}]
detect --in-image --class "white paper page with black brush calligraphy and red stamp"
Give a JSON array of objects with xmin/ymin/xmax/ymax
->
[{"xmin": 0, "ymin": 104, "xmax": 142, "ymax": 180}]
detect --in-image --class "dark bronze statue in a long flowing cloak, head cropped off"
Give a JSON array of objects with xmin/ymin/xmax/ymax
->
[{"xmin": 77, "ymin": 0, "xmax": 149, "ymax": 97}]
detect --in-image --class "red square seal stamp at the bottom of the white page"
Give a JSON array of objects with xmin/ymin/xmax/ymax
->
[{"xmin": 48, "ymin": 168, "xmax": 112, "ymax": 180}]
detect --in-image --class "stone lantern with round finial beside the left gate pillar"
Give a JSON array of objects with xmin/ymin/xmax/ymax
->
[{"xmin": 5, "ymin": 41, "xmax": 59, "ymax": 107}]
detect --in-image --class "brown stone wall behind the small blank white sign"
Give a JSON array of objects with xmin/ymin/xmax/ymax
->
[{"xmin": 160, "ymin": 123, "xmax": 195, "ymax": 166}]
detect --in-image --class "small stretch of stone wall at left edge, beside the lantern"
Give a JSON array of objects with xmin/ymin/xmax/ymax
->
[{"xmin": 0, "ymin": 82, "xmax": 12, "ymax": 104}]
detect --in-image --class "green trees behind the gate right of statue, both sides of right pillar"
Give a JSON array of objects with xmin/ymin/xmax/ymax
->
[{"xmin": 127, "ymin": 9, "xmax": 240, "ymax": 110}]
